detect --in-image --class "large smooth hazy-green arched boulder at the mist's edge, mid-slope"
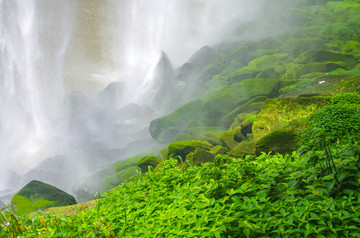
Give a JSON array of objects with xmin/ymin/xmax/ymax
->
[{"xmin": 202, "ymin": 79, "xmax": 279, "ymax": 120}]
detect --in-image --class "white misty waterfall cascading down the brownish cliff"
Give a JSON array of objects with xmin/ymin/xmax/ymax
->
[{"xmin": 0, "ymin": 0, "xmax": 256, "ymax": 201}]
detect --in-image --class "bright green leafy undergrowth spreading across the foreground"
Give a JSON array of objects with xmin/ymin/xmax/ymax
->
[{"xmin": 0, "ymin": 144, "xmax": 360, "ymax": 237}]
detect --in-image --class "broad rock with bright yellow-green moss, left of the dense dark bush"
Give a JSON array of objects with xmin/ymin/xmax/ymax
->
[{"xmin": 252, "ymin": 97, "xmax": 330, "ymax": 142}]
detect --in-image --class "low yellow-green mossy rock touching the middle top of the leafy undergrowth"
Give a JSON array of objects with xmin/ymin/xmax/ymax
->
[{"xmin": 168, "ymin": 140, "xmax": 213, "ymax": 160}]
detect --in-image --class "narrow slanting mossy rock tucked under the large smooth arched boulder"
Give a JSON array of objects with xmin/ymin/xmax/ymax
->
[{"xmin": 223, "ymin": 96, "xmax": 267, "ymax": 127}]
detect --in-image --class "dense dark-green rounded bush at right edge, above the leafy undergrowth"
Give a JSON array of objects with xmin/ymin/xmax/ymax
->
[{"xmin": 301, "ymin": 103, "xmax": 360, "ymax": 150}]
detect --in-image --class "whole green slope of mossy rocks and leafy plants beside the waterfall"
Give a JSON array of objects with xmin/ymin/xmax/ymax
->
[{"xmin": 0, "ymin": 0, "xmax": 360, "ymax": 237}]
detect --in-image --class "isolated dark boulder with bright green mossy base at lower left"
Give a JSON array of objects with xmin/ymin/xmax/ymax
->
[{"xmin": 11, "ymin": 180, "xmax": 76, "ymax": 216}]
